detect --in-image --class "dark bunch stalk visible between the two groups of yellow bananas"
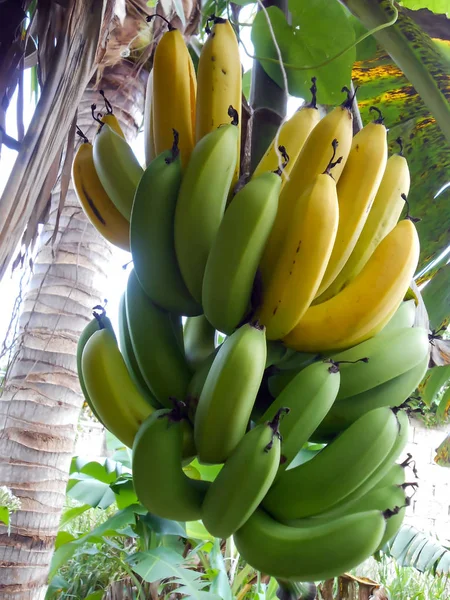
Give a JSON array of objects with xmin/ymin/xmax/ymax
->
[{"xmin": 250, "ymin": 0, "xmax": 288, "ymax": 172}]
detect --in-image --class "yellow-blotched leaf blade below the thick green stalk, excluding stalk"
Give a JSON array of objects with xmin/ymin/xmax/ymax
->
[{"xmin": 353, "ymin": 47, "xmax": 450, "ymax": 274}]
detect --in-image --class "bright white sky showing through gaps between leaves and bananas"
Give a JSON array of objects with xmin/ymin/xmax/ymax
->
[{"xmin": 0, "ymin": 11, "xmax": 302, "ymax": 364}]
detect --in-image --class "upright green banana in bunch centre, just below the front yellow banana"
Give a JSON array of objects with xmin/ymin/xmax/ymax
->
[{"xmin": 194, "ymin": 323, "xmax": 266, "ymax": 463}]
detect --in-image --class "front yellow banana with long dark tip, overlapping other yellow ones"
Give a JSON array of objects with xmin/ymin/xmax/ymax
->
[{"xmin": 257, "ymin": 146, "xmax": 339, "ymax": 340}]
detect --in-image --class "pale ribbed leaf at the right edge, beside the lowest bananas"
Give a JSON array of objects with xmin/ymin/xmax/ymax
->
[{"xmin": 384, "ymin": 525, "xmax": 450, "ymax": 575}]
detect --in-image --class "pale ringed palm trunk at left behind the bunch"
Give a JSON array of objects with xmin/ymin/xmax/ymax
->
[{"xmin": 0, "ymin": 61, "xmax": 147, "ymax": 600}]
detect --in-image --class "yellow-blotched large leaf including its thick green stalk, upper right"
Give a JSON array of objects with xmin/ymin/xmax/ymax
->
[{"xmin": 344, "ymin": 0, "xmax": 450, "ymax": 268}]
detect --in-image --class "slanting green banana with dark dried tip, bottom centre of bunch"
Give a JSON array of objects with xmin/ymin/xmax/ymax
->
[{"xmin": 202, "ymin": 409, "xmax": 288, "ymax": 538}]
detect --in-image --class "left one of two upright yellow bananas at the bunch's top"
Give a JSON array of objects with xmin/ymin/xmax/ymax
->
[{"xmin": 152, "ymin": 25, "xmax": 197, "ymax": 167}]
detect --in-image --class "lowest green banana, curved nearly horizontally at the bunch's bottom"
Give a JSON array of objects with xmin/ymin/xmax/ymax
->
[{"xmin": 234, "ymin": 508, "xmax": 386, "ymax": 581}]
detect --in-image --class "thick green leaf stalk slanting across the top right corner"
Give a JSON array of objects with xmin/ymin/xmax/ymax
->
[{"xmin": 342, "ymin": 0, "xmax": 450, "ymax": 142}]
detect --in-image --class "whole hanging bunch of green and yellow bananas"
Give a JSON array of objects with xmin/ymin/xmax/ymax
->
[{"xmin": 73, "ymin": 18, "xmax": 429, "ymax": 581}]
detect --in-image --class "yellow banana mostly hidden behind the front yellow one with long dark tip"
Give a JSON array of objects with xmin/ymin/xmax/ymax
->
[{"xmin": 260, "ymin": 94, "xmax": 353, "ymax": 279}]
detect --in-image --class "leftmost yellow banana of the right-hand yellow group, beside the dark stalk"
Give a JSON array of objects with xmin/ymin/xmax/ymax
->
[{"xmin": 252, "ymin": 77, "xmax": 320, "ymax": 188}]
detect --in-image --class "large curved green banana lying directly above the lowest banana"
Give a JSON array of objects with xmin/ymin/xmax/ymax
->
[{"xmin": 262, "ymin": 408, "xmax": 399, "ymax": 520}]
